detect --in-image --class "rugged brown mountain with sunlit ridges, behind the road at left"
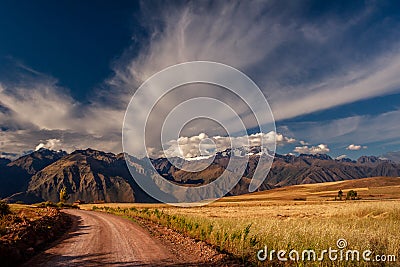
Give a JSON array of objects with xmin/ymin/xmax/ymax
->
[{"xmin": 27, "ymin": 149, "xmax": 154, "ymax": 202}]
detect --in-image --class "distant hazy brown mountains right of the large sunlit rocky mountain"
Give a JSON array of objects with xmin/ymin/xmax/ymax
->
[{"xmin": 152, "ymin": 153, "xmax": 400, "ymax": 195}]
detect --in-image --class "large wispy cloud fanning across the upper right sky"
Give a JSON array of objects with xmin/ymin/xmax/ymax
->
[{"xmin": 110, "ymin": 1, "xmax": 400, "ymax": 120}]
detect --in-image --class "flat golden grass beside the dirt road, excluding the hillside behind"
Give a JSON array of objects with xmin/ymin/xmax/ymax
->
[{"xmin": 92, "ymin": 200, "xmax": 400, "ymax": 266}]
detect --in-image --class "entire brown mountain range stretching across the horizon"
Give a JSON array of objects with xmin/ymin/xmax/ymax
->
[{"xmin": 0, "ymin": 149, "xmax": 400, "ymax": 203}]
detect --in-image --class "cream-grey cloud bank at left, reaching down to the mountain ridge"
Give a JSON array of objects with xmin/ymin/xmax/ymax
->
[{"xmin": 0, "ymin": 77, "xmax": 124, "ymax": 155}]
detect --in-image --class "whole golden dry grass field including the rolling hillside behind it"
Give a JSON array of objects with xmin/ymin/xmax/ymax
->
[{"xmin": 84, "ymin": 177, "xmax": 400, "ymax": 266}]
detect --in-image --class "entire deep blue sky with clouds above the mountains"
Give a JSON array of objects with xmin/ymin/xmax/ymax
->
[{"xmin": 0, "ymin": 0, "xmax": 400, "ymax": 159}]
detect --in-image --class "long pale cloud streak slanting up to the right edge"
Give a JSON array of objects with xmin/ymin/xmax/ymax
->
[{"xmin": 271, "ymin": 50, "xmax": 400, "ymax": 119}]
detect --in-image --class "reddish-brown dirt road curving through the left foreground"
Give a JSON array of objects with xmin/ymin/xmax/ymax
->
[{"xmin": 23, "ymin": 210, "xmax": 176, "ymax": 267}]
